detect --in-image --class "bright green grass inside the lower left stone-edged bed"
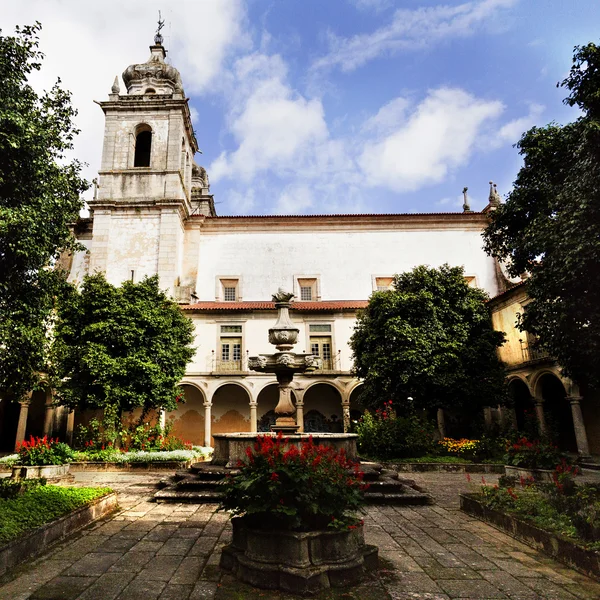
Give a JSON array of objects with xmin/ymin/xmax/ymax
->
[{"xmin": 0, "ymin": 485, "xmax": 112, "ymax": 544}]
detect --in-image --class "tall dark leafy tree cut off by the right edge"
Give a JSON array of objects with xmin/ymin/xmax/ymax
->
[{"xmin": 484, "ymin": 44, "xmax": 600, "ymax": 387}]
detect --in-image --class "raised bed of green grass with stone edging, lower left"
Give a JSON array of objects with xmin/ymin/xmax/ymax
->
[{"xmin": 0, "ymin": 486, "xmax": 117, "ymax": 576}]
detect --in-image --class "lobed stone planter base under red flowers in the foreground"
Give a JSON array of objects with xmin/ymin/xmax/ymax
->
[{"xmin": 220, "ymin": 518, "xmax": 378, "ymax": 595}]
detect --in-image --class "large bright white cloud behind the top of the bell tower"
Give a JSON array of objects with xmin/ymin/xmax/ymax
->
[{"xmin": 2, "ymin": 0, "xmax": 248, "ymax": 196}]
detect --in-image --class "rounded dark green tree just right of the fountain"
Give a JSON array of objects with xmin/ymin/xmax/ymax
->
[{"xmin": 350, "ymin": 265, "xmax": 505, "ymax": 412}]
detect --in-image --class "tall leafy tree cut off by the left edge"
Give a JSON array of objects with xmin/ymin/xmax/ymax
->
[{"xmin": 0, "ymin": 23, "xmax": 87, "ymax": 399}]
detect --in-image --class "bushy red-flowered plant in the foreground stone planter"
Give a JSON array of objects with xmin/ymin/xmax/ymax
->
[{"xmin": 220, "ymin": 434, "xmax": 367, "ymax": 531}]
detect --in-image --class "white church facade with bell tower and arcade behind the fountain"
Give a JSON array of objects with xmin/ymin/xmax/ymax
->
[{"xmin": 57, "ymin": 39, "xmax": 502, "ymax": 445}]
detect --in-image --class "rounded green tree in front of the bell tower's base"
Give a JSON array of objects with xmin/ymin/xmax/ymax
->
[{"xmin": 53, "ymin": 273, "xmax": 194, "ymax": 426}]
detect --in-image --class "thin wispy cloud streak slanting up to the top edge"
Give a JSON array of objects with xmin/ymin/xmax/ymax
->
[{"xmin": 313, "ymin": 0, "xmax": 518, "ymax": 71}]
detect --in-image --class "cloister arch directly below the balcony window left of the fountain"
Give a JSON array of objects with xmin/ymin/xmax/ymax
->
[{"xmin": 211, "ymin": 381, "xmax": 252, "ymax": 434}]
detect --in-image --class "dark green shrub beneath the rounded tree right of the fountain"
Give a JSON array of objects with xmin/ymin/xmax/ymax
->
[{"xmin": 355, "ymin": 400, "xmax": 437, "ymax": 460}]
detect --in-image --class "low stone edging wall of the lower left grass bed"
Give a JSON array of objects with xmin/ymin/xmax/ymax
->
[{"xmin": 0, "ymin": 493, "xmax": 117, "ymax": 576}]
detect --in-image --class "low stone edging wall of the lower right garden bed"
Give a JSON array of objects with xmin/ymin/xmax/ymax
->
[{"xmin": 460, "ymin": 494, "xmax": 600, "ymax": 580}]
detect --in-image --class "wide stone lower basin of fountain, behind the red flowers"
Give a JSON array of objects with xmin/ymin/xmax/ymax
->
[{"xmin": 211, "ymin": 432, "xmax": 358, "ymax": 468}]
